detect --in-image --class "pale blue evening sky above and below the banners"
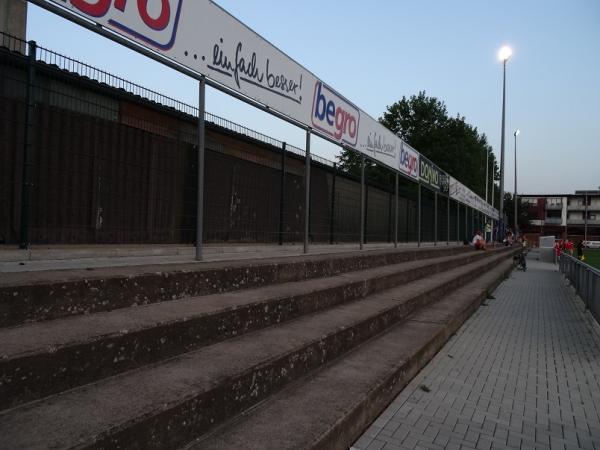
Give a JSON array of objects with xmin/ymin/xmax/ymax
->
[{"xmin": 27, "ymin": 0, "xmax": 600, "ymax": 193}]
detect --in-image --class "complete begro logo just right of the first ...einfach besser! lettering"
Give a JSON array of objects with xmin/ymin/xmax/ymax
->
[{"xmin": 312, "ymin": 81, "xmax": 360, "ymax": 146}]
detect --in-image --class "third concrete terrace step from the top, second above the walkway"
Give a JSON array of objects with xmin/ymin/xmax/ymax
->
[{"xmin": 0, "ymin": 252, "xmax": 511, "ymax": 449}]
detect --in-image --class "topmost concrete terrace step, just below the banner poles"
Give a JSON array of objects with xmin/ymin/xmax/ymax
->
[{"xmin": 0, "ymin": 247, "xmax": 472, "ymax": 327}]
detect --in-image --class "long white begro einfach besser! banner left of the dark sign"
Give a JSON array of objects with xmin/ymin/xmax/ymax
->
[{"xmin": 39, "ymin": 0, "xmax": 419, "ymax": 178}]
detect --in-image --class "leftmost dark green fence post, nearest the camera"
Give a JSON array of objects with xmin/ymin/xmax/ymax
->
[{"xmin": 19, "ymin": 41, "xmax": 37, "ymax": 249}]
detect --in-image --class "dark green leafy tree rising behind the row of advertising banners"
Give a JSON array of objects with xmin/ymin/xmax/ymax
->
[{"xmin": 338, "ymin": 91, "xmax": 499, "ymax": 205}]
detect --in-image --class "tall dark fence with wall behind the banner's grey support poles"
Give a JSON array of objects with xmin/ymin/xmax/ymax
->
[{"xmin": 0, "ymin": 30, "xmax": 482, "ymax": 247}]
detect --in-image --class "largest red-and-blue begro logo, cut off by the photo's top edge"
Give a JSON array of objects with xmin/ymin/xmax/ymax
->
[{"xmin": 60, "ymin": 0, "xmax": 183, "ymax": 50}]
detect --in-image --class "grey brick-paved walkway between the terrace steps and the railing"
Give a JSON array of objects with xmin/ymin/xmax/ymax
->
[{"xmin": 353, "ymin": 260, "xmax": 600, "ymax": 450}]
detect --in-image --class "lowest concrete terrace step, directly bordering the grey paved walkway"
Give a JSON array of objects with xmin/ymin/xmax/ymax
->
[{"xmin": 185, "ymin": 261, "xmax": 512, "ymax": 450}]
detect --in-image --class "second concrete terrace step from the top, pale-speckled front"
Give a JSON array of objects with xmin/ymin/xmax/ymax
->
[{"xmin": 0, "ymin": 250, "xmax": 504, "ymax": 409}]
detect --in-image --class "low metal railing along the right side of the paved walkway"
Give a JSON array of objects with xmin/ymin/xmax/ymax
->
[{"xmin": 559, "ymin": 253, "xmax": 600, "ymax": 323}]
